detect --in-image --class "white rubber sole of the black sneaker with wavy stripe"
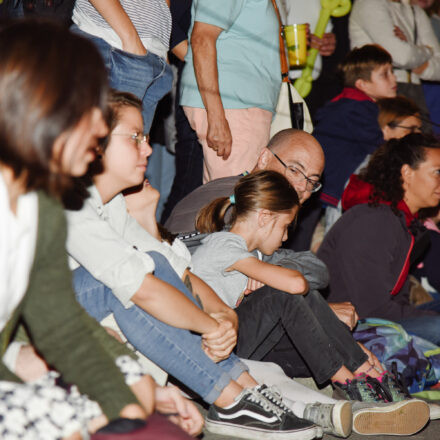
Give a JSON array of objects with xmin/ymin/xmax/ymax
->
[{"xmin": 205, "ymin": 419, "xmax": 321, "ymax": 440}]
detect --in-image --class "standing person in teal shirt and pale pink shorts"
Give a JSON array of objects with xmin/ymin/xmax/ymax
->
[{"xmin": 180, "ymin": 0, "xmax": 281, "ymax": 182}]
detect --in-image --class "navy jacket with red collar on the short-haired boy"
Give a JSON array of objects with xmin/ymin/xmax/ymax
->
[{"xmin": 313, "ymin": 88, "xmax": 383, "ymax": 206}]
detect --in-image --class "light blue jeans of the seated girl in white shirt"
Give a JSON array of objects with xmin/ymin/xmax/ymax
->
[{"xmin": 73, "ymin": 252, "xmax": 247, "ymax": 403}]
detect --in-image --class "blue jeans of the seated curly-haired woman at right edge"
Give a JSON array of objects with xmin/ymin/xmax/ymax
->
[{"xmin": 397, "ymin": 299, "xmax": 440, "ymax": 345}]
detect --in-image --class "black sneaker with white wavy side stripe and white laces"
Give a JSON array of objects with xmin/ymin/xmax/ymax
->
[{"xmin": 205, "ymin": 388, "xmax": 320, "ymax": 440}]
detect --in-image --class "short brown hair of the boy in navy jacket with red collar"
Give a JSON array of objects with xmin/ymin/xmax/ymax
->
[{"xmin": 340, "ymin": 44, "xmax": 393, "ymax": 87}]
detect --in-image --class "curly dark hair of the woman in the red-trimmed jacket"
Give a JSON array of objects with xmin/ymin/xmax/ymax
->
[{"xmin": 359, "ymin": 133, "xmax": 440, "ymax": 212}]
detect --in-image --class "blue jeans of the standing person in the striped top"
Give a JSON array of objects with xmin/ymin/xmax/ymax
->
[{"xmin": 72, "ymin": 25, "xmax": 173, "ymax": 133}]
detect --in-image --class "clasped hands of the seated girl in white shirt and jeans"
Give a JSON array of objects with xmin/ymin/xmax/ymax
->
[{"xmin": 202, "ymin": 313, "xmax": 237, "ymax": 362}]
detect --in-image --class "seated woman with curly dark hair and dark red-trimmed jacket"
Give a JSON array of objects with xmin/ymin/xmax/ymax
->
[{"xmin": 318, "ymin": 133, "xmax": 440, "ymax": 345}]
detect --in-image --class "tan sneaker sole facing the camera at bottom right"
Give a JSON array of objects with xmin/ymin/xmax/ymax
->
[{"xmin": 353, "ymin": 399, "xmax": 429, "ymax": 435}]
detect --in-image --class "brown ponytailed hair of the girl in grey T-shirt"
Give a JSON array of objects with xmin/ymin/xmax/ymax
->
[{"xmin": 196, "ymin": 170, "xmax": 299, "ymax": 233}]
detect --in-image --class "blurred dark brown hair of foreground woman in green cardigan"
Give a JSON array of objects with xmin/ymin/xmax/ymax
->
[{"xmin": 0, "ymin": 20, "xmax": 107, "ymax": 195}]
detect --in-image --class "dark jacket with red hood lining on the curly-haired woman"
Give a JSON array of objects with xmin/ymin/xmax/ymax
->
[{"xmin": 318, "ymin": 179, "xmax": 435, "ymax": 321}]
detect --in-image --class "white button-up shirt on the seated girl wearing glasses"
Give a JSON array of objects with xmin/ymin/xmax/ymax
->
[{"xmin": 66, "ymin": 185, "xmax": 191, "ymax": 307}]
